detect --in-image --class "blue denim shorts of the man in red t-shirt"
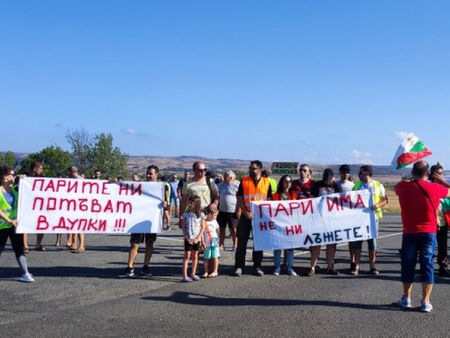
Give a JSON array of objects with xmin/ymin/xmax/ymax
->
[{"xmin": 401, "ymin": 232, "xmax": 436, "ymax": 283}]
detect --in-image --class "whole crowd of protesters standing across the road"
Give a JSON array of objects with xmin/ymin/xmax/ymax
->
[{"xmin": 0, "ymin": 161, "xmax": 450, "ymax": 312}]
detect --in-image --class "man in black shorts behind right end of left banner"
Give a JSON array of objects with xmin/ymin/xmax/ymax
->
[{"xmin": 119, "ymin": 165, "xmax": 168, "ymax": 278}]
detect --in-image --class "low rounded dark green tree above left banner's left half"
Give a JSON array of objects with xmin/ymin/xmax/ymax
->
[{"xmin": 20, "ymin": 146, "xmax": 72, "ymax": 177}]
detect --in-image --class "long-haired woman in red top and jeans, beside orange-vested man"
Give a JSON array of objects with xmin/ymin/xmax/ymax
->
[{"xmin": 272, "ymin": 175, "xmax": 297, "ymax": 276}]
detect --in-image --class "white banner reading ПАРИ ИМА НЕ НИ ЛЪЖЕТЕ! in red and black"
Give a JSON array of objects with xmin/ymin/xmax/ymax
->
[{"xmin": 250, "ymin": 189, "xmax": 377, "ymax": 250}]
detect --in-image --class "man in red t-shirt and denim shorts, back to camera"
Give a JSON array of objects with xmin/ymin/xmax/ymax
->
[{"xmin": 395, "ymin": 161, "xmax": 450, "ymax": 312}]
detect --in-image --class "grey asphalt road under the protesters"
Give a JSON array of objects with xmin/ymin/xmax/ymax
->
[{"xmin": 0, "ymin": 215, "xmax": 450, "ymax": 337}]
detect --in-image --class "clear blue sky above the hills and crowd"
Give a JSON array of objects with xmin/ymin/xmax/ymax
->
[{"xmin": 0, "ymin": 0, "xmax": 450, "ymax": 167}]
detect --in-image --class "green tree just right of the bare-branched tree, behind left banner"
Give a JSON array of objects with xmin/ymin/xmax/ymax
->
[{"xmin": 89, "ymin": 133, "xmax": 128, "ymax": 178}]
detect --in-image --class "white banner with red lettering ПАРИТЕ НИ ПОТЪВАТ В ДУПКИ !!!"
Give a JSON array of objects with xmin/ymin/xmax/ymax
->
[{"xmin": 17, "ymin": 177, "xmax": 164, "ymax": 234}]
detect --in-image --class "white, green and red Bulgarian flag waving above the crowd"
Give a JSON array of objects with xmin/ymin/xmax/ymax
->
[{"xmin": 392, "ymin": 133, "xmax": 431, "ymax": 169}]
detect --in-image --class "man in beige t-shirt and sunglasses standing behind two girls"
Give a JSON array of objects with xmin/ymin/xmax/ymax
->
[{"xmin": 178, "ymin": 162, "xmax": 219, "ymax": 229}]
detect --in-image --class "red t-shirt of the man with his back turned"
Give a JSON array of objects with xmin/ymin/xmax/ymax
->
[{"xmin": 395, "ymin": 181, "xmax": 448, "ymax": 234}]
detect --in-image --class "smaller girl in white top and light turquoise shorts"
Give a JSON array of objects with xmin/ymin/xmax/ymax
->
[{"xmin": 202, "ymin": 207, "xmax": 220, "ymax": 278}]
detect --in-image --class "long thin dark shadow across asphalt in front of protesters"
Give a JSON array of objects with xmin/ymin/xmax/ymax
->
[{"xmin": 142, "ymin": 291, "xmax": 402, "ymax": 311}]
